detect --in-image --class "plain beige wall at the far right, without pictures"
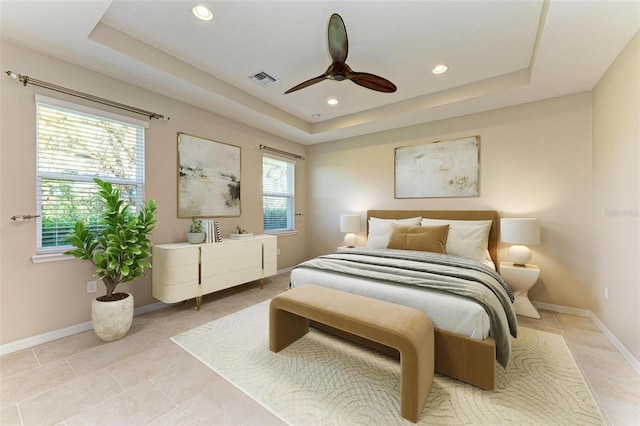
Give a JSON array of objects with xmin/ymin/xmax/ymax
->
[{"xmin": 592, "ymin": 33, "xmax": 640, "ymax": 359}]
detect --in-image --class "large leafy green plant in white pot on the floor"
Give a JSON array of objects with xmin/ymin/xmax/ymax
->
[{"xmin": 65, "ymin": 178, "xmax": 157, "ymax": 342}]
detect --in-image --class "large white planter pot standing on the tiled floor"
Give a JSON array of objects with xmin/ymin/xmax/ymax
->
[{"xmin": 91, "ymin": 293, "xmax": 133, "ymax": 342}]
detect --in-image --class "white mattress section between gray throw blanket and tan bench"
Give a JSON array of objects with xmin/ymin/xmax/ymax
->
[{"xmin": 291, "ymin": 268, "xmax": 489, "ymax": 340}]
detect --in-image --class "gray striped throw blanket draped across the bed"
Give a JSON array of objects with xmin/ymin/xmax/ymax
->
[{"xmin": 296, "ymin": 249, "xmax": 517, "ymax": 367}]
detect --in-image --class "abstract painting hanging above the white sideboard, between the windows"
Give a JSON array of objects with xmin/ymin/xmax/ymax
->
[{"xmin": 178, "ymin": 133, "xmax": 240, "ymax": 218}]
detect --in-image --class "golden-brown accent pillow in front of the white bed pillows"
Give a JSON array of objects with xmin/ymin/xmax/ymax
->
[{"xmin": 387, "ymin": 225, "xmax": 449, "ymax": 253}]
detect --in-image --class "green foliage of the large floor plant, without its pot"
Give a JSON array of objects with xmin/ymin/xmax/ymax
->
[{"xmin": 65, "ymin": 178, "xmax": 157, "ymax": 301}]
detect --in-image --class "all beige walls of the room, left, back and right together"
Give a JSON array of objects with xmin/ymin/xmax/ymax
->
[{"xmin": 0, "ymin": 35, "xmax": 640, "ymax": 358}]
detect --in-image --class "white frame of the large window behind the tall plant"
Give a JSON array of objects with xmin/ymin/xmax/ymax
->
[{"xmin": 32, "ymin": 95, "xmax": 149, "ymax": 263}]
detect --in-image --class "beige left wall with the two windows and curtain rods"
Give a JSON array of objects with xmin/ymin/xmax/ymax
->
[{"xmin": 0, "ymin": 42, "xmax": 306, "ymax": 344}]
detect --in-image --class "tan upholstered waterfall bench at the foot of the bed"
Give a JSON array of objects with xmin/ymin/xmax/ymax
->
[{"xmin": 269, "ymin": 284, "xmax": 434, "ymax": 423}]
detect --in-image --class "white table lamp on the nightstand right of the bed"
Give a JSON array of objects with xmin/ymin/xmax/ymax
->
[{"xmin": 500, "ymin": 218, "xmax": 540, "ymax": 266}]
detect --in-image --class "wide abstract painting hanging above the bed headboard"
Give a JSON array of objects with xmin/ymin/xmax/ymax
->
[{"xmin": 395, "ymin": 136, "xmax": 480, "ymax": 198}]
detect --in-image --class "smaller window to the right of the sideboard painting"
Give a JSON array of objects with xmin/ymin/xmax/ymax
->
[{"xmin": 262, "ymin": 155, "xmax": 296, "ymax": 233}]
